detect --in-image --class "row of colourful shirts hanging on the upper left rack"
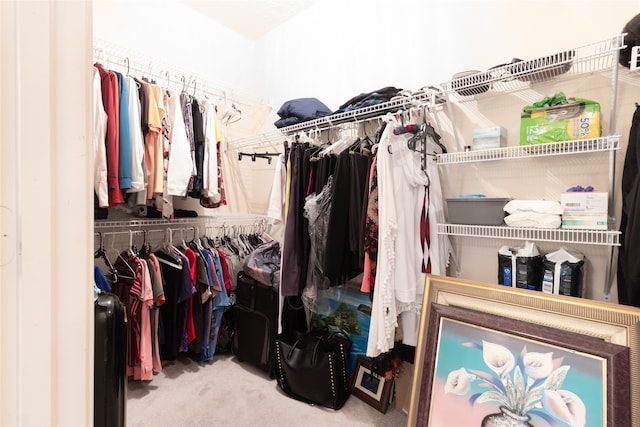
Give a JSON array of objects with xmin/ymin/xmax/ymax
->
[{"xmin": 93, "ymin": 63, "xmax": 226, "ymax": 219}]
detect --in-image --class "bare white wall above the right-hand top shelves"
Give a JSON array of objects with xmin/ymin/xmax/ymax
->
[{"xmin": 255, "ymin": 0, "xmax": 640, "ymax": 122}]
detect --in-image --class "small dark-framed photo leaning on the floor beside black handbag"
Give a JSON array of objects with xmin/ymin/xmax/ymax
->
[{"xmin": 351, "ymin": 356, "xmax": 393, "ymax": 414}]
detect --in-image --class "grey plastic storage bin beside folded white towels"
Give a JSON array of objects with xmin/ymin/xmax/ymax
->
[{"xmin": 447, "ymin": 197, "xmax": 510, "ymax": 225}]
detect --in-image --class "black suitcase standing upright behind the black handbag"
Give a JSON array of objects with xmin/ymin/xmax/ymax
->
[{"xmin": 232, "ymin": 271, "xmax": 278, "ymax": 378}]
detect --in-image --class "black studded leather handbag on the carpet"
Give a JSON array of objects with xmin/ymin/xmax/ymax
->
[{"xmin": 276, "ymin": 331, "xmax": 351, "ymax": 409}]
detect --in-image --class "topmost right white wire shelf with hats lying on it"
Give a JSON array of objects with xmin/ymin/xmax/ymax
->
[{"xmin": 440, "ymin": 34, "xmax": 625, "ymax": 99}]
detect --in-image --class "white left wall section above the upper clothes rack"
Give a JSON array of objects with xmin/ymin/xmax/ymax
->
[{"xmin": 93, "ymin": 0, "xmax": 258, "ymax": 95}]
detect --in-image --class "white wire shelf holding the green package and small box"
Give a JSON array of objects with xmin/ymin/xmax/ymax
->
[{"xmin": 436, "ymin": 135, "xmax": 620, "ymax": 165}]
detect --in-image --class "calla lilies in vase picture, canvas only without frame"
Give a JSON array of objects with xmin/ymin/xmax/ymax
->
[{"xmin": 432, "ymin": 319, "xmax": 606, "ymax": 427}]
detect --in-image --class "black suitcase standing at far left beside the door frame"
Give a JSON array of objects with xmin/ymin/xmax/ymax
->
[{"xmin": 93, "ymin": 293, "xmax": 127, "ymax": 427}]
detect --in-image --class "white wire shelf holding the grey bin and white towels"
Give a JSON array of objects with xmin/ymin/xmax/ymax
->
[{"xmin": 438, "ymin": 223, "xmax": 620, "ymax": 246}]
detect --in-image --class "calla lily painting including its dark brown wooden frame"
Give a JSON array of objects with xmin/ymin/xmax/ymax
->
[{"xmin": 417, "ymin": 303, "xmax": 630, "ymax": 427}]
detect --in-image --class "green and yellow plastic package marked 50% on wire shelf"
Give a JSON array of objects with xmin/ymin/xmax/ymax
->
[{"xmin": 520, "ymin": 98, "xmax": 602, "ymax": 145}]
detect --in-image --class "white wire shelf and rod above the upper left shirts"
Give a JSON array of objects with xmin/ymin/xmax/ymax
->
[{"xmin": 93, "ymin": 37, "xmax": 268, "ymax": 106}]
